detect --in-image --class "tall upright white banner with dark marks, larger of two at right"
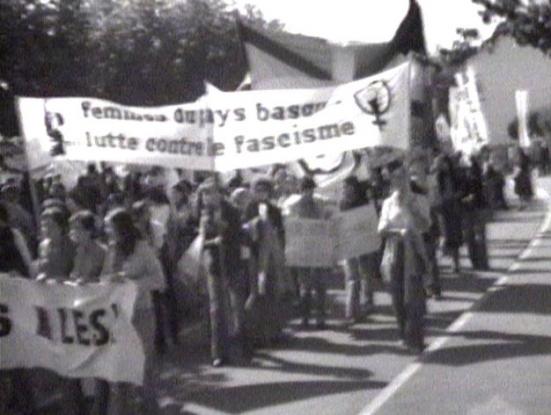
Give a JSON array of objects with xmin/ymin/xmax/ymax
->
[{"xmin": 449, "ymin": 67, "xmax": 489, "ymax": 155}]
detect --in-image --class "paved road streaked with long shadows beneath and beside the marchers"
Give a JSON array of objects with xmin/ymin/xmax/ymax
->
[{"xmin": 149, "ymin": 182, "xmax": 551, "ymax": 415}]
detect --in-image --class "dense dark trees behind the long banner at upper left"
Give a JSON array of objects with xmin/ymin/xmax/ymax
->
[{"xmin": 0, "ymin": 0, "xmax": 282, "ymax": 134}]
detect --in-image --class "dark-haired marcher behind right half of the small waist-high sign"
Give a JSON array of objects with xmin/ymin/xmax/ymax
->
[{"xmin": 339, "ymin": 176, "xmax": 379, "ymax": 323}]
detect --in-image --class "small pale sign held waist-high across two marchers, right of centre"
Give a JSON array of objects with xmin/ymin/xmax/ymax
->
[{"xmin": 285, "ymin": 204, "xmax": 381, "ymax": 268}]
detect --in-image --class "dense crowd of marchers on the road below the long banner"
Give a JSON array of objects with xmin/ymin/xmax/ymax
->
[{"xmin": 0, "ymin": 141, "xmax": 533, "ymax": 414}]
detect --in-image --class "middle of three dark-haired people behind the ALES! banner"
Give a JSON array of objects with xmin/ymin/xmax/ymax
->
[{"xmin": 69, "ymin": 210, "xmax": 107, "ymax": 283}]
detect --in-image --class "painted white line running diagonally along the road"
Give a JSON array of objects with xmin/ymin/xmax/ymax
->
[{"xmin": 360, "ymin": 190, "xmax": 551, "ymax": 415}]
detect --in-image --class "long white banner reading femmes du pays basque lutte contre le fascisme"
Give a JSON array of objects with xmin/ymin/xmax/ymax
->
[{"xmin": 18, "ymin": 63, "xmax": 410, "ymax": 171}]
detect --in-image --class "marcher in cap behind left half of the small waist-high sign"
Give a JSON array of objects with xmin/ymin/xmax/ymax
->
[{"xmin": 289, "ymin": 176, "xmax": 329, "ymax": 329}]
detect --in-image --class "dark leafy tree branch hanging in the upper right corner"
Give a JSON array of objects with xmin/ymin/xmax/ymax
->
[{"xmin": 472, "ymin": 0, "xmax": 551, "ymax": 55}]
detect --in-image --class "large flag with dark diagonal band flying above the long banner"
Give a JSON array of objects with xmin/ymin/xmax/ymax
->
[{"xmin": 238, "ymin": 0, "xmax": 425, "ymax": 89}]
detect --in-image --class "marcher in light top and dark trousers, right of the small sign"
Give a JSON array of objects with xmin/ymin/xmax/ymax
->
[{"xmin": 379, "ymin": 161, "xmax": 430, "ymax": 353}]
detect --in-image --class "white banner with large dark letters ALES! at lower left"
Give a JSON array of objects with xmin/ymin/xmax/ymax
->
[{"xmin": 0, "ymin": 274, "xmax": 144, "ymax": 384}]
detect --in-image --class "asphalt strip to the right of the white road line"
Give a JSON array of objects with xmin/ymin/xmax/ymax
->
[{"xmin": 362, "ymin": 178, "xmax": 551, "ymax": 415}]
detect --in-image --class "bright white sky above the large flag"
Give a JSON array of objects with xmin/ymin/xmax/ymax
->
[{"xmin": 231, "ymin": 0, "xmax": 498, "ymax": 53}]
